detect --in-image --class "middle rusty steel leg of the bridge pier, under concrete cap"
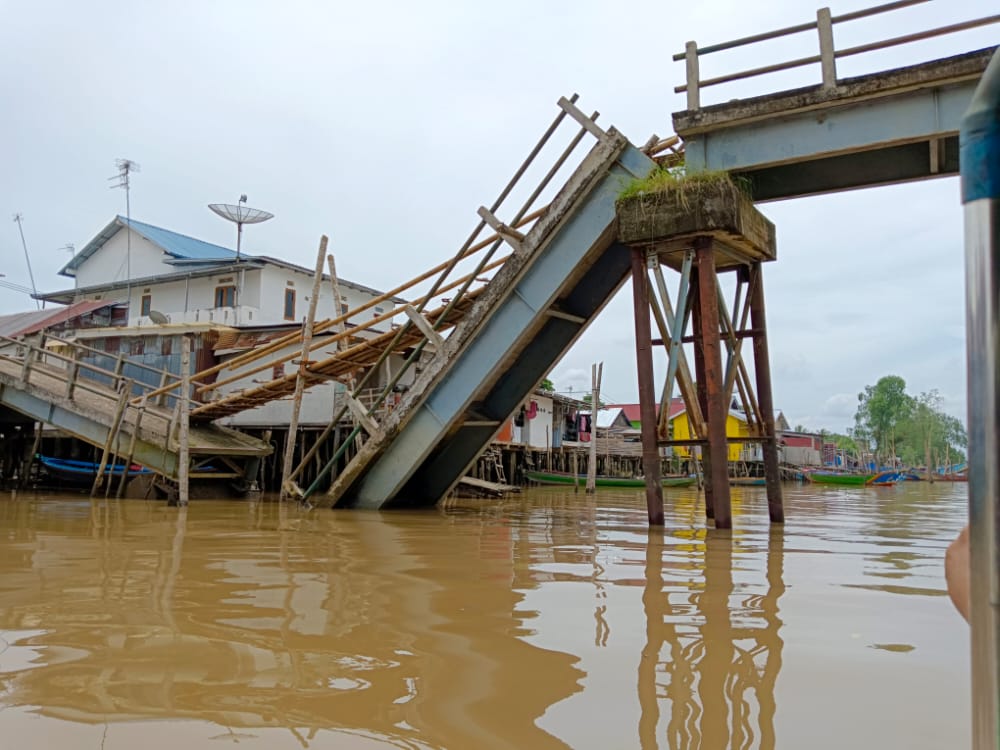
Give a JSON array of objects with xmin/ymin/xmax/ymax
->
[{"xmin": 694, "ymin": 237, "xmax": 733, "ymax": 529}]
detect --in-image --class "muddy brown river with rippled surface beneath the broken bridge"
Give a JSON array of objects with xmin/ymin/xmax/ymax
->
[{"xmin": 0, "ymin": 482, "xmax": 970, "ymax": 750}]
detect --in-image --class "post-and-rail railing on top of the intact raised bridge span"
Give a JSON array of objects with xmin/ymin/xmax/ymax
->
[{"xmin": 673, "ymin": 0, "xmax": 1000, "ymax": 110}]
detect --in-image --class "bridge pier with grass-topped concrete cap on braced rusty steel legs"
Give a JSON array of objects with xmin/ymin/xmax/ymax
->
[{"xmin": 618, "ymin": 179, "xmax": 784, "ymax": 529}]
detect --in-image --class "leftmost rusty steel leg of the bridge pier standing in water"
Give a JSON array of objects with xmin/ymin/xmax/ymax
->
[{"xmin": 631, "ymin": 247, "xmax": 663, "ymax": 526}]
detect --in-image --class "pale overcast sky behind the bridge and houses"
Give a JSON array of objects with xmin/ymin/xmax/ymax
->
[{"xmin": 0, "ymin": 0, "xmax": 1000, "ymax": 430}]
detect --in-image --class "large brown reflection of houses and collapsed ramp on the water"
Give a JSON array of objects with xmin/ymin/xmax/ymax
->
[{"xmin": 0, "ymin": 501, "xmax": 580, "ymax": 747}]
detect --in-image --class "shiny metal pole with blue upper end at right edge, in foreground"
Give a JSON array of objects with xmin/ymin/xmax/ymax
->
[{"xmin": 959, "ymin": 48, "xmax": 1000, "ymax": 750}]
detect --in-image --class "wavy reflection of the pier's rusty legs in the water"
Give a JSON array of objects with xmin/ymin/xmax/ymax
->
[{"xmin": 638, "ymin": 527, "xmax": 785, "ymax": 749}]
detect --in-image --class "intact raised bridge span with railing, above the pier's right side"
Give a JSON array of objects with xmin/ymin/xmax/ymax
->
[{"xmin": 673, "ymin": 2, "xmax": 1000, "ymax": 201}]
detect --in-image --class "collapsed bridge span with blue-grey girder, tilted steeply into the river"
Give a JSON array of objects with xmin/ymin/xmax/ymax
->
[{"xmin": 312, "ymin": 99, "xmax": 655, "ymax": 508}]
